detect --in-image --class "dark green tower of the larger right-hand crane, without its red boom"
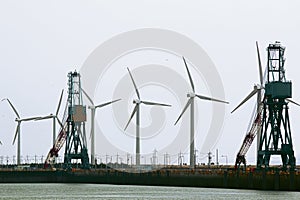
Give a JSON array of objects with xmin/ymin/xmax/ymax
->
[{"xmin": 257, "ymin": 42, "xmax": 296, "ymax": 169}]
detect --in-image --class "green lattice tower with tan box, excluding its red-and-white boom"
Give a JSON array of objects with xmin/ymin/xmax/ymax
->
[{"xmin": 64, "ymin": 71, "xmax": 90, "ymax": 168}]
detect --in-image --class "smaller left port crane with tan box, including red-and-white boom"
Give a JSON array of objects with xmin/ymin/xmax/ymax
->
[{"xmin": 45, "ymin": 71, "xmax": 90, "ymax": 168}]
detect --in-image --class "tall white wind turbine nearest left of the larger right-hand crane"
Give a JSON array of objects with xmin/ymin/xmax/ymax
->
[{"xmin": 174, "ymin": 57, "xmax": 228, "ymax": 167}]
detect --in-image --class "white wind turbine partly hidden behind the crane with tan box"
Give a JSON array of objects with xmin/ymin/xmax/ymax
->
[{"xmin": 81, "ymin": 88, "xmax": 121, "ymax": 165}]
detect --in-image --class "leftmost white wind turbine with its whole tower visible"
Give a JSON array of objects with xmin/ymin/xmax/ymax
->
[{"xmin": 2, "ymin": 98, "xmax": 37, "ymax": 165}]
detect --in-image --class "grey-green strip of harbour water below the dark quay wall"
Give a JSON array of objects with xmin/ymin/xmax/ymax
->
[{"xmin": 0, "ymin": 184, "xmax": 300, "ymax": 200}]
